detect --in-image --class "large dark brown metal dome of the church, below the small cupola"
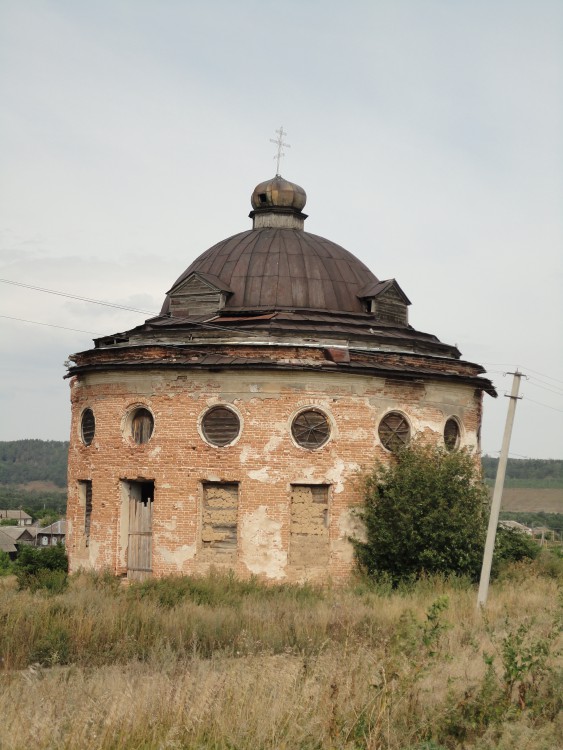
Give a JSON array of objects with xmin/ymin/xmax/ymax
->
[{"xmin": 161, "ymin": 227, "xmax": 384, "ymax": 314}]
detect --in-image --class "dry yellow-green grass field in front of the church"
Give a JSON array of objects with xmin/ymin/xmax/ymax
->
[{"xmin": 0, "ymin": 564, "xmax": 563, "ymax": 750}]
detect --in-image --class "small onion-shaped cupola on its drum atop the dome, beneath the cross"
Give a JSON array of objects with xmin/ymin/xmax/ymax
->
[{"xmin": 249, "ymin": 175, "xmax": 307, "ymax": 229}]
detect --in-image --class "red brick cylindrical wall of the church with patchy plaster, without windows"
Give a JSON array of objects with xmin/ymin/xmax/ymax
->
[{"xmin": 67, "ymin": 368, "xmax": 481, "ymax": 580}]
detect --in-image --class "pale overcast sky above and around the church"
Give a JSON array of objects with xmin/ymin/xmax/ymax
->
[{"xmin": 0, "ymin": 0, "xmax": 563, "ymax": 458}]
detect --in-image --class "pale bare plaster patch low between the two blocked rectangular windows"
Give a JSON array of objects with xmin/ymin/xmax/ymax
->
[{"xmin": 240, "ymin": 505, "xmax": 287, "ymax": 579}]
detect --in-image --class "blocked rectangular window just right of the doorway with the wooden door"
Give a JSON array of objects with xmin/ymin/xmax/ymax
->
[{"xmin": 201, "ymin": 482, "xmax": 238, "ymax": 555}]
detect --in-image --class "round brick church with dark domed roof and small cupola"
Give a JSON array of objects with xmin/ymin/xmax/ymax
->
[{"xmin": 67, "ymin": 175, "xmax": 495, "ymax": 581}]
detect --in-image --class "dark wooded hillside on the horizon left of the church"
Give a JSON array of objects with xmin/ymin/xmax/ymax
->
[{"xmin": 0, "ymin": 440, "xmax": 68, "ymax": 487}]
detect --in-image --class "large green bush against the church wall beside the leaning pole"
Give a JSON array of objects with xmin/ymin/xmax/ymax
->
[{"xmin": 355, "ymin": 444, "xmax": 488, "ymax": 586}]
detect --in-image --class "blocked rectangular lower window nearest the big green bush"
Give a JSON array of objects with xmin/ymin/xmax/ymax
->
[{"xmin": 289, "ymin": 484, "xmax": 329, "ymax": 568}]
